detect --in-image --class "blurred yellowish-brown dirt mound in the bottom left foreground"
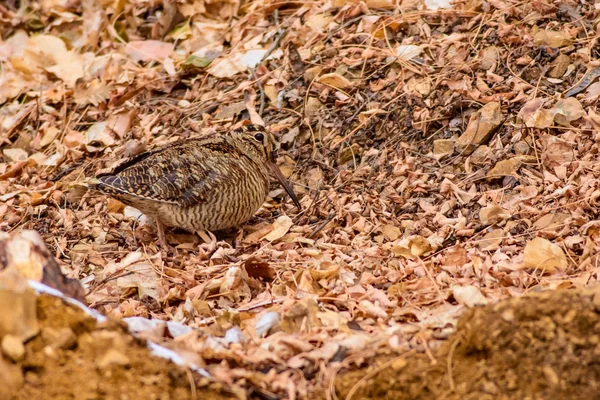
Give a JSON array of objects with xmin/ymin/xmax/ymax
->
[{"xmin": 0, "ymin": 295, "xmax": 235, "ymax": 400}]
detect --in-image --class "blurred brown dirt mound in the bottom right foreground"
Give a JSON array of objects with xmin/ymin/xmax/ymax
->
[{"xmin": 329, "ymin": 288, "xmax": 600, "ymax": 400}]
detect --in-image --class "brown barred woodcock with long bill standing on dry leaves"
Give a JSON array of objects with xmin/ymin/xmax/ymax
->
[{"xmin": 90, "ymin": 125, "xmax": 300, "ymax": 246}]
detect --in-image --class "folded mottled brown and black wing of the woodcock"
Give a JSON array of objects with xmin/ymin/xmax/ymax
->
[{"xmin": 97, "ymin": 140, "xmax": 243, "ymax": 207}]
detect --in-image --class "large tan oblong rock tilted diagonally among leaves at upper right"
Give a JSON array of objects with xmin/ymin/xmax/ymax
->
[{"xmin": 456, "ymin": 101, "xmax": 504, "ymax": 155}]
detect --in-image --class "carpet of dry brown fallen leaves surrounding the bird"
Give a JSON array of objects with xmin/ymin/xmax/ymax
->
[{"xmin": 0, "ymin": 0, "xmax": 600, "ymax": 398}]
